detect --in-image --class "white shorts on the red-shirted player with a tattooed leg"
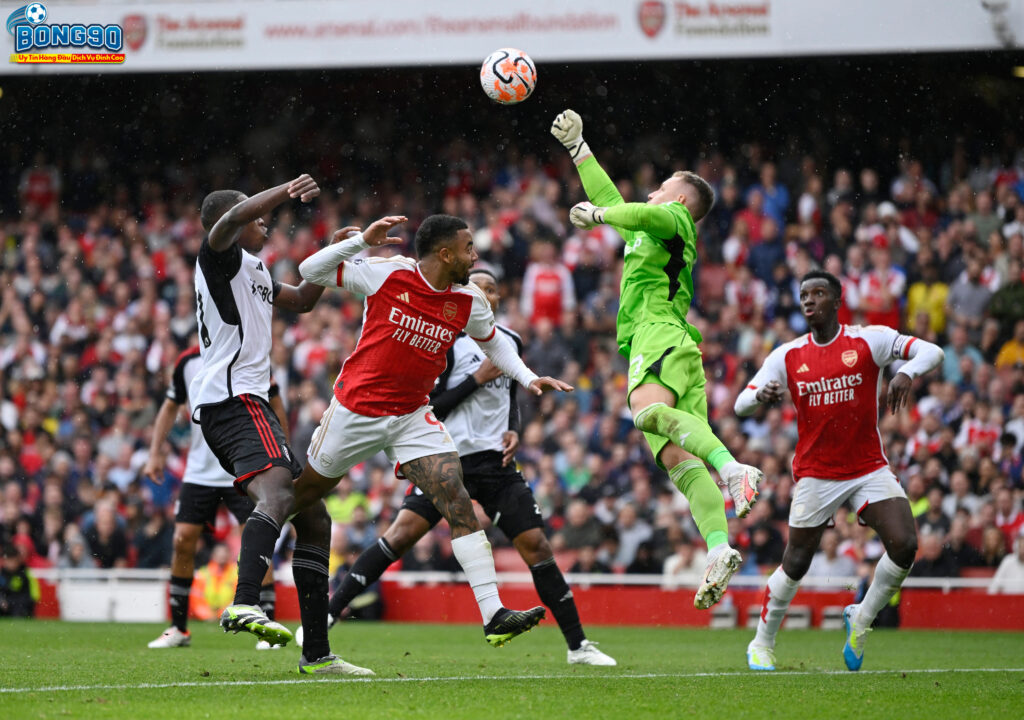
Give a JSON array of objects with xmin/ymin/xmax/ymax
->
[{"xmin": 306, "ymin": 398, "xmax": 457, "ymax": 477}]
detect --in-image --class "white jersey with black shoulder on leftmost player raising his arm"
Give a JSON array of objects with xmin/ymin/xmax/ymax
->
[{"xmin": 188, "ymin": 240, "xmax": 281, "ymax": 422}]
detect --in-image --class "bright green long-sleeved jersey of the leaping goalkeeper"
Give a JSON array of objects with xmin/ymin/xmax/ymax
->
[{"xmin": 579, "ymin": 156, "xmax": 701, "ymax": 357}]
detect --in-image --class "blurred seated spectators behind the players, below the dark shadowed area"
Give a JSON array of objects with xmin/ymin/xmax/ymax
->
[{"xmin": 0, "ymin": 99, "xmax": 1024, "ymax": 613}]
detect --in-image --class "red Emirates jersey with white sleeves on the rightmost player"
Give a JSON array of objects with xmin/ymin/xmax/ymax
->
[{"xmin": 748, "ymin": 325, "xmax": 915, "ymax": 480}]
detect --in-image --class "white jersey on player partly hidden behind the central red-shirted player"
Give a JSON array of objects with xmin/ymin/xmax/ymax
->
[{"xmin": 431, "ymin": 326, "xmax": 522, "ymax": 457}]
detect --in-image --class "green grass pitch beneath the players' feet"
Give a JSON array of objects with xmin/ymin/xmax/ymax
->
[{"xmin": 0, "ymin": 620, "xmax": 1024, "ymax": 720}]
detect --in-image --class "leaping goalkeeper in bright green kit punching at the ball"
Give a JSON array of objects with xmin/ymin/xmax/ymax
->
[{"xmin": 551, "ymin": 110, "xmax": 762, "ymax": 609}]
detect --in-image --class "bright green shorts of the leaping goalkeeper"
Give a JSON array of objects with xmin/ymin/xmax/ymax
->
[{"xmin": 627, "ymin": 323, "xmax": 708, "ymax": 465}]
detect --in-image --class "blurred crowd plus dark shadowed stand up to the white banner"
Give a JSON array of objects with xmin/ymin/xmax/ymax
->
[{"xmin": 0, "ymin": 60, "xmax": 1024, "ymax": 618}]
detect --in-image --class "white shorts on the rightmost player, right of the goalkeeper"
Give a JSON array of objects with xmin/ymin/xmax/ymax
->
[{"xmin": 790, "ymin": 467, "xmax": 906, "ymax": 527}]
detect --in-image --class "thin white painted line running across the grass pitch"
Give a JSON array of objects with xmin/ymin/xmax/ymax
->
[{"xmin": 0, "ymin": 668, "xmax": 1024, "ymax": 694}]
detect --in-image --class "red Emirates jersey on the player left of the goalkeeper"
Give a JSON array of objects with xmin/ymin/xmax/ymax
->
[{"xmin": 334, "ymin": 256, "xmax": 495, "ymax": 417}]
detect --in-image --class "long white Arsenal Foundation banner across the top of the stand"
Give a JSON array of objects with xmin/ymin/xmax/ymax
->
[{"xmin": 0, "ymin": 0, "xmax": 1024, "ymax": 74}]
